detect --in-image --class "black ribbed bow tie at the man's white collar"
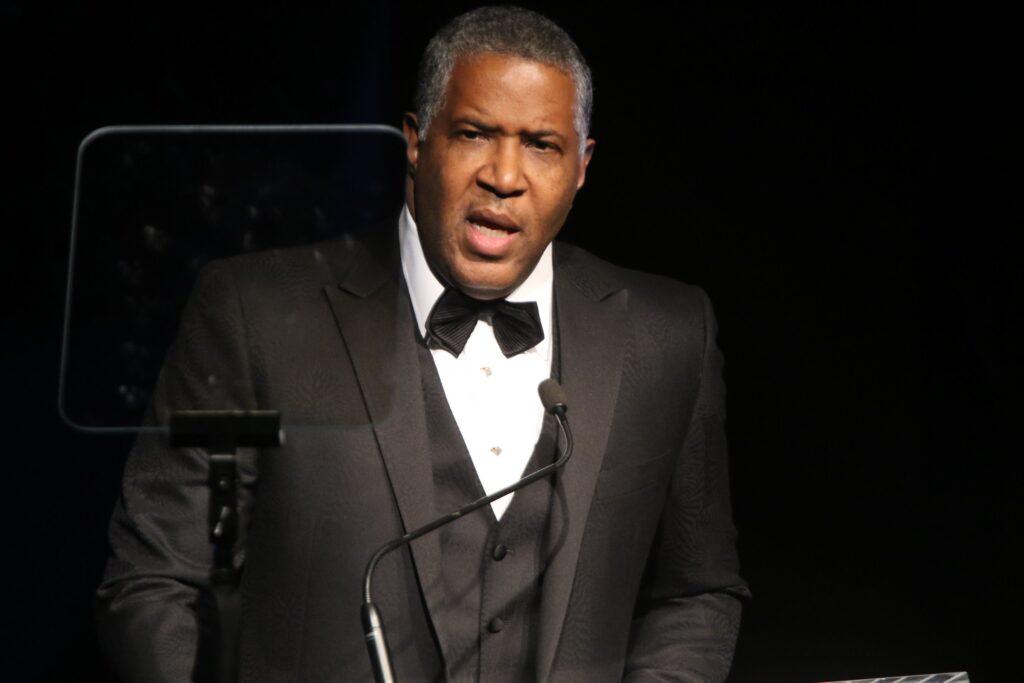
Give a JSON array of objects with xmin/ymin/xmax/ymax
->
[{"xmin": 427, "ymin": 290, "xmax": 544, "ymax": 358}]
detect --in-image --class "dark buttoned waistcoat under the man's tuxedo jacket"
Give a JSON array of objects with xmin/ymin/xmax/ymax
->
[{"xmin": 420, "ymin": 337, "xmax": 559, "ymax": 683}]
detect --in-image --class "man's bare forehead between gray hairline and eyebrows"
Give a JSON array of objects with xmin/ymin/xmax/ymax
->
[{"xmin": 444, "ymin": 52, "xmax": 575, "ymax": 128}]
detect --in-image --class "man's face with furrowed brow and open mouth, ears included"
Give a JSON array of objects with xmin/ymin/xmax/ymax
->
[{"xmin": 404, "ymin": 53, "xmax": 593, "ymax": 299}]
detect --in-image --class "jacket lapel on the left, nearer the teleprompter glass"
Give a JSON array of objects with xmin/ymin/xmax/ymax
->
[{"xmin": 324, "ymin": 235, "xmax": 443, "ymax": 667}]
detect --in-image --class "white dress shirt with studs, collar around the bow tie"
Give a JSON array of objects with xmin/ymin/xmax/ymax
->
[{"xmin": 398, "ymin": 206, "xmax": 553, "ymax": 519}]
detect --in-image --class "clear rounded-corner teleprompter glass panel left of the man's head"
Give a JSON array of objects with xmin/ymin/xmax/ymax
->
[{"xmin": 58, "ymin": 125, "xmax": 406, "ymax": 431}]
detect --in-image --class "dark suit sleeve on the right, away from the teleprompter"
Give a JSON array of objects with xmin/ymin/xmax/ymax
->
[{"xmin": 624, "ymin": 292, "xmax": 750, "ymax": 683}]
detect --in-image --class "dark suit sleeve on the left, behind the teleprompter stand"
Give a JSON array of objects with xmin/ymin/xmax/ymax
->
[{"xmin": 95, "ymin": 262, "xmax": 256, "ymax": 683}]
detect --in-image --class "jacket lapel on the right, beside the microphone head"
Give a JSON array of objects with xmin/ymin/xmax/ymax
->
[{"xmin": 538, "ymin": 245, "xmax": 628, "ymax": 681}]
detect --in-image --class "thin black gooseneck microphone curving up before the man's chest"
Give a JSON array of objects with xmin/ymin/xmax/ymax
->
[{"xmin": 361, "ymin": 379, "xmax": 572, "ymax": 683}]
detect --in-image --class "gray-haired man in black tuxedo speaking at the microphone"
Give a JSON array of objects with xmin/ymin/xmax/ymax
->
[{"xmin": 99, "ymin": 8, "xmax": 746, "ymax": 681}]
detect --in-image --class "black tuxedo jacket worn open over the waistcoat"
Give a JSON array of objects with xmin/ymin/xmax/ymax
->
[{"xmin": 97, "ymin": 226, "xmax": 746, "ymax": 682}]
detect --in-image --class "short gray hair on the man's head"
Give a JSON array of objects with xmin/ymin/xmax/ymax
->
[{"xmin": 413, "ymin": 6, "xmax": 594, "ymax": 156}]
